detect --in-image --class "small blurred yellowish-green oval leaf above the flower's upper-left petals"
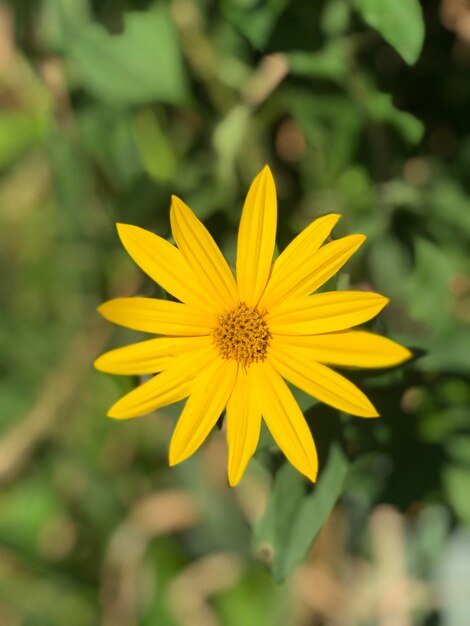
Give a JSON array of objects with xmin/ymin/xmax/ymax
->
[{"xmin": 134, "ymin": 111, "xmax": 177, "ymax": 182}]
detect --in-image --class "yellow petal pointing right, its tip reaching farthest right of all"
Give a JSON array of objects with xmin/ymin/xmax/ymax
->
[{"xmin": 271, "ymin": 330, "xmax": 412, "ymax": 368}]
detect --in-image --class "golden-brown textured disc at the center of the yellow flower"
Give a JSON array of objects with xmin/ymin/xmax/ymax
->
[{"xmin": 212, "ymin": 302, "xmax": 271, "ymax": 367}]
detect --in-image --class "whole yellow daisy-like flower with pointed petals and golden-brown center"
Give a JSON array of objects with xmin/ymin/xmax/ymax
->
[{"xmin": 95, "ymin": 166, "xmax": 410, "ymax": 485}]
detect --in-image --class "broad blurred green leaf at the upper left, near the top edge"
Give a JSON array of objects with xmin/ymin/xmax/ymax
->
[{"xmin": 64, "ymin": 6, "xmax": 186, "ymax": 105}]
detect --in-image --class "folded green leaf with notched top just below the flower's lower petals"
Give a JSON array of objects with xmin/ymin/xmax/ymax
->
[{"xmin": 255, "ymin": 445, "xmax": 349, "ymax": 581}]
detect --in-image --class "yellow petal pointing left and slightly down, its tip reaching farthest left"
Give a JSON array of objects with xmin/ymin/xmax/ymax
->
[{"xmin": 94, "ymin": 335, "xmax": 212, "ymax": 376}]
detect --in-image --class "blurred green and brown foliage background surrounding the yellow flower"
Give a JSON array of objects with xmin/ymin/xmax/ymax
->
[{"xmin": 0, "ymin": 0, "xmax": 470, "ymax": 626}]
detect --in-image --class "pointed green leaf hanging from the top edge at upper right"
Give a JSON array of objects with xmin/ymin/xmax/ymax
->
[{"xmin": 355, "ymin": 0, "xmax": 424, "ymax": 65}]
